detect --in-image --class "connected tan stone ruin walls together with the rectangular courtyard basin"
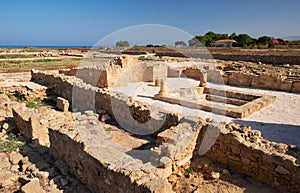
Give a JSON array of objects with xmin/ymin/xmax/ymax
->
[{"xmin": 0, "ymin": 55, "xmax": 300, "ymax": 193}]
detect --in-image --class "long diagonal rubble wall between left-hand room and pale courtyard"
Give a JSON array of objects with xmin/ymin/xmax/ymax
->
[{"xmin": 32, "ymin": 70, "xmax": 180, "ymax": 133}]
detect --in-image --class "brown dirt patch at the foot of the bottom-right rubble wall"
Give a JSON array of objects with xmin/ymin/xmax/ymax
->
[{"xmin": 170, "ymin": 157, "xmax": 283, "ymax": 193}]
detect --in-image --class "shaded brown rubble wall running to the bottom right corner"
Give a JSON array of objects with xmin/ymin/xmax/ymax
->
[{"xmin": 192, "ymin": 123, "xmax": 300, "ymax": 192}]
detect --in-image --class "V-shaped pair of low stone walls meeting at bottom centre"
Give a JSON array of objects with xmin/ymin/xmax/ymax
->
[{"xmin": 49, "ymin": 115, "xmax": 204, "ymax": 193}]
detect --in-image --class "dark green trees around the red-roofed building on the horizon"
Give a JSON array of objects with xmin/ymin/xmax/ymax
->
[{"xmin": 175, "ymin": 31, "xmax": 300, "ymax": 48}]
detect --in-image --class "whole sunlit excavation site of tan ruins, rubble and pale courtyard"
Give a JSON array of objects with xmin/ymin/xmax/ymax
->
[{"xmin": 0, "ymin": 53, "xmax": 300, "ymax": 193}]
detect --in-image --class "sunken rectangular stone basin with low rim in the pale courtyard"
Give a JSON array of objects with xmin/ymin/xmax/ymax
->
[{"xmin": 154, "ymin": 87, "xmax": 276, "ymax": 118}]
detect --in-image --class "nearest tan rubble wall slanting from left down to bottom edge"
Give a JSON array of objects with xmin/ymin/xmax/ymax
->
[{"xmin": 14, "ymin": 107, "xmax": 172, "ymax": 193}]
